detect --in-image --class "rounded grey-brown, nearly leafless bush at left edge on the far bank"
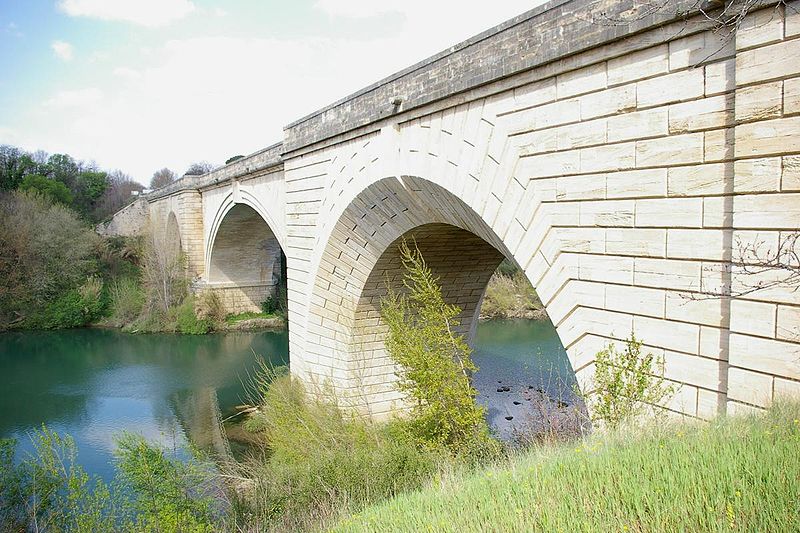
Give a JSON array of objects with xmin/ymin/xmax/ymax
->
[{"xmin": 0, "ymin": 191, "xmax": 100, "ymax": 326}]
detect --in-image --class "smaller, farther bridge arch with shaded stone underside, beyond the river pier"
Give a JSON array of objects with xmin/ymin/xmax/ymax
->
[{"xmin": 202, "ymin": 200, "xmax": 286, "ymax": 313}]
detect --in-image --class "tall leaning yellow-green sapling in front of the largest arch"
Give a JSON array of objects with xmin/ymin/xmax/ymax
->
[{"xmin": 381, "ymin": 242, "xmax": 493, "ymax": 455}]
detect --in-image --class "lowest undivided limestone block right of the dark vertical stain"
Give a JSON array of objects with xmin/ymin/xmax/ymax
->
[{"xmin": 729, "ymin": 333, "xmax": 800, "ymax": 378}]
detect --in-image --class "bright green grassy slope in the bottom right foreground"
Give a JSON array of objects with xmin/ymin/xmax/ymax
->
[{"xmin": 333, "ymin": 404, "xmax": 800, "ymax": 532}]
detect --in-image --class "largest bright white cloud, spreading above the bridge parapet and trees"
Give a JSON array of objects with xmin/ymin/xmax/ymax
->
[{"xmin": 23, "ymin": 0, "xmax": 552, "ymax": 183}]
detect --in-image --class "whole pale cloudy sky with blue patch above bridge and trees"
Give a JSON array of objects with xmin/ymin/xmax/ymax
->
[{"xmin": 0, "ymin": 0, "xmax": 544, "ymax": 184}]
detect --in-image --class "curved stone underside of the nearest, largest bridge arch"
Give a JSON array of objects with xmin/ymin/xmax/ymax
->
[{"xmin": 302, "ymin": 176, "xmax": 575, "ymax": 415}]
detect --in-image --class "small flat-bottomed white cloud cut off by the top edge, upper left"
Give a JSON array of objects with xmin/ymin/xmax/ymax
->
[{"xmin": 58, "ymin": 0, "xmax": 195, "ymax": 27}]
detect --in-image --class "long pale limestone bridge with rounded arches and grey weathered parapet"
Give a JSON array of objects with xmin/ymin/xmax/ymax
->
[{"xmin": 106, "ymin": 0, "xmax": 800, "ymax": 418}]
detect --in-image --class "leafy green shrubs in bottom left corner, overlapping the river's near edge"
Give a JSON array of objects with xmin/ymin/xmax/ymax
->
[{"xmin": 0, "ymin": 427, "xmax": 219, "ymax": 533}]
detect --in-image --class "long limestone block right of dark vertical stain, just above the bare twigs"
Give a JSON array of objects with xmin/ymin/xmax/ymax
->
[{"xmin": 733, "ymin": 193, "xmax": 800, "ymax": 229}]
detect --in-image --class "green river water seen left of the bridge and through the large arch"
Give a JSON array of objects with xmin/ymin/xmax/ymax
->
[{"xmin": 0, "ymin": 321, "xmax": 574, "ymax": 479}]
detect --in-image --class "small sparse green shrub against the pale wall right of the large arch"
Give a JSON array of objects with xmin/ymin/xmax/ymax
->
[{"xmin": 584, "ymin": 333, "xmax": 675, "ymax": 429}]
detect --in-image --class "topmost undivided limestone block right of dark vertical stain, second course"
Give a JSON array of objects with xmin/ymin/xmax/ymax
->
[{"xmin": 736, "ymin": 39, "xmax": 800, "ymax": 86}]
